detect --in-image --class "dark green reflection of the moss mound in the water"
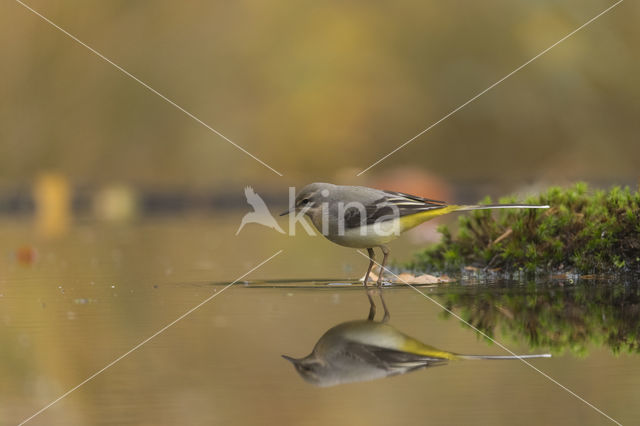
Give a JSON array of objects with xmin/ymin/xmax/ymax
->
[{"xmin": 439, "ymin": 282, "xmax": 640, "ymax": 355}]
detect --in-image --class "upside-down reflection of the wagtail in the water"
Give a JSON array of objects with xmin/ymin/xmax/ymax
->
[{"xmin": 282, "ymin": 290, "xmax": 551, "ymax": 387}]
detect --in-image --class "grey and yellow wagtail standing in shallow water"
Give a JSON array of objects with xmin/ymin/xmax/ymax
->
[{"xmin": 280, "ymin": 183, "xmax": 549, "ymax": 287}]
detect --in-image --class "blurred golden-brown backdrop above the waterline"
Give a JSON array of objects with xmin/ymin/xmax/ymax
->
[{"xmin": 0, "ymin": 0, "xmax": 640, "ymax": 216}]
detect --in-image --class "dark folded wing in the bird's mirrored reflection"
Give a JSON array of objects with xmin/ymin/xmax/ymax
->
[{"xmin": 344, "ymin": 342, "xmax": 448, "ymax": 374}]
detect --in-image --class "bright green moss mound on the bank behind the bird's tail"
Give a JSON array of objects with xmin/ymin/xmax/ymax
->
[{"xmin": 407, "ymin": 183, "xmax": 640, "ymax": 274}]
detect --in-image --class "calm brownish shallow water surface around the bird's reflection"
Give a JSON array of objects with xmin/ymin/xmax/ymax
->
[{"xmin": 0, "ymin": 217, "xmax": 640, "ymax": 425}]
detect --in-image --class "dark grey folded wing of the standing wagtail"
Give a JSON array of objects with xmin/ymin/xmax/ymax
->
[{"xmin": 344, "ymin": 191, "xmax": 447, "ymax": 229}]
